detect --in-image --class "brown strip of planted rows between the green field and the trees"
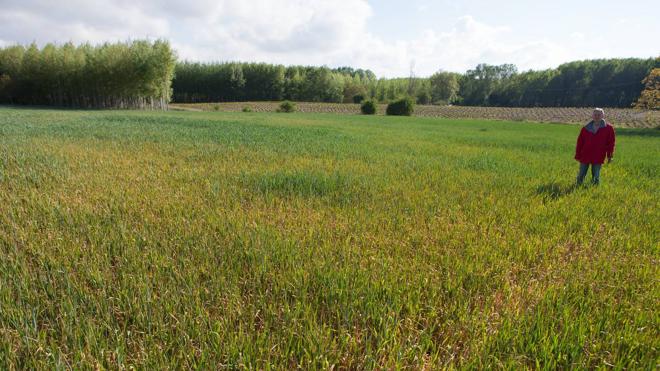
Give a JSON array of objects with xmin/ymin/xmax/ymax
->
[{"xmin": 170, "ymin": 102, "xmax": 660, "ymax": 128}]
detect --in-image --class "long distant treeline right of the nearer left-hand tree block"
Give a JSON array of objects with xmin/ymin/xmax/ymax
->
[{"xmin": 173, "ymin": 58, "xmax": 660, "ymax": 107}]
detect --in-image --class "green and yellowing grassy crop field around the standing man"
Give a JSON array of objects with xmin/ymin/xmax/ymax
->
[{"xmin": 0, "ymin": 108, "xmax": 660, "ymax": 369}]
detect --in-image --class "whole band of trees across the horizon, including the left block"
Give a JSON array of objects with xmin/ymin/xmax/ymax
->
[{"xmin": 0, "ymin": 40, "xmax": 660, "ymax": 109}]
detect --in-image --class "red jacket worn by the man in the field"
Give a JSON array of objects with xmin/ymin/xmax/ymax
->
[{"xmin": 575, "ymin": 121, "xmax": 615, "ymax": 164}]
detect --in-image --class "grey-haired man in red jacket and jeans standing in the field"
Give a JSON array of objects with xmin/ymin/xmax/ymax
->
[{"xmin": 575, "ymin": 108, "xmax": 615, "ymax": 185}]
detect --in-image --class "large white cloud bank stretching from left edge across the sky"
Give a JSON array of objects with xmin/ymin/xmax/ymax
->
[{"xmin": 0, "ymin": 0, "xmax": 640, "ymax": 77}]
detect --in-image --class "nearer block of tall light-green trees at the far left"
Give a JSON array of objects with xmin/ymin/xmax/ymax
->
[{"xmin": 0, "ymin": 40, "xmax": 176, "ymax": 109}]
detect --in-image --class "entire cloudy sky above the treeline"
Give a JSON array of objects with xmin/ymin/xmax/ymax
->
[{"xmin": 0, "ymin": 0, "xmax": 660, "ymax": 77}]
